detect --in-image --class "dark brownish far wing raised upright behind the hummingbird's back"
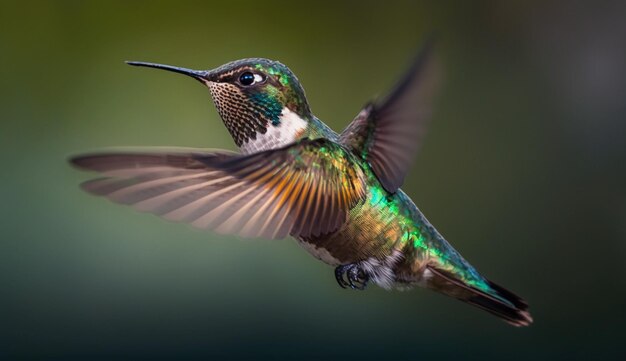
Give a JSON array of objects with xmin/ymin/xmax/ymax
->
[{"xmin": 340, "ymin": 40, "xmax": 438, "ymax": 193}]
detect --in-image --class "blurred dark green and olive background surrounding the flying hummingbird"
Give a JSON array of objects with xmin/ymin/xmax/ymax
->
[{"xmin": 0, "ymin": 1, "xmax": 626, "ymax": 360}]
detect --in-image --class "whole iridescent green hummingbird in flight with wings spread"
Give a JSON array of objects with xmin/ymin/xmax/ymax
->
[{"xmin": 70, "ymin": 42, "xmax": 532, "ymax": 326}]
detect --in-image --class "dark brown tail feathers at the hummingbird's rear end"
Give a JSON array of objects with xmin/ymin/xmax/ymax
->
[{"xmin": 428, "ymin": 267, "xmax": 533, "ymax": 327}]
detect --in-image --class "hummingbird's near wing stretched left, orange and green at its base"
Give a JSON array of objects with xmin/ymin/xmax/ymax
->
[{"xmin": 71, "ymin": 139, "xmax": 365, "ymax": 239}]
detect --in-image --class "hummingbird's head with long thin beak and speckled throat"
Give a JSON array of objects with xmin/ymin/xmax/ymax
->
[{"xmin": 128, "ymin": 58, "xmax": 311, "ymax": 147}]
